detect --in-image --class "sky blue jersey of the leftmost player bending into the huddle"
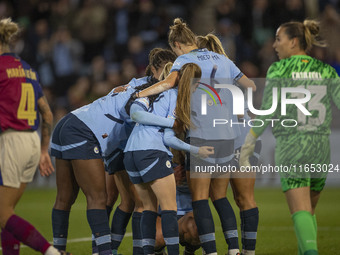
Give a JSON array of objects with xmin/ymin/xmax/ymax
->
[{"xmin": 72, "ymin": 77, "xmax": 147, "ymax": 157}]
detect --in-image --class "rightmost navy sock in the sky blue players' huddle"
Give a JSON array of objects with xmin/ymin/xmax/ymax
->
[{"xmin": 240, "ymin": 207, "xmax": 259, "ymax": 254}]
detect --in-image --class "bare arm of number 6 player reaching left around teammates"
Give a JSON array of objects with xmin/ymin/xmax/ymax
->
[{"xmin": 136, "ymin": 71, "xmax": 179, "ymax": 97}]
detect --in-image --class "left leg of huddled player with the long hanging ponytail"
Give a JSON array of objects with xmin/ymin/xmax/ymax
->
[{"xmin": 135, "ymin": 183, "xmax": 158, "ymax": 254}]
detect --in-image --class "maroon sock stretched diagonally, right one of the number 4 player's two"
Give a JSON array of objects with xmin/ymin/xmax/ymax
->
[{"xmin": 5, "ymin": 214, "xmax": 51, "ymax": 254}]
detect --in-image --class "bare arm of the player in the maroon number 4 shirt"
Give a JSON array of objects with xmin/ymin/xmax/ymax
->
[{"xmin": 38, "ymin": 96, "xmax": 54, "ymax": 176}]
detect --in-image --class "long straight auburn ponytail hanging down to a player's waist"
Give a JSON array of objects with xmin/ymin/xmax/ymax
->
[{"xmin": 175, "ymin": 63, "xmax": 202, "ymax": 133}]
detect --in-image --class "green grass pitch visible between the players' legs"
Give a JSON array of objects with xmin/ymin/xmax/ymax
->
[{"xmin": 7, "ymin": 186, "xmax": 340, "ymax": 255}]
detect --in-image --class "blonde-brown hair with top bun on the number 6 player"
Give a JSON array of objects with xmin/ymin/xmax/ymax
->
[{"xmin": 168, "ymin": 18, "xmax": 196, "ymax": 47}]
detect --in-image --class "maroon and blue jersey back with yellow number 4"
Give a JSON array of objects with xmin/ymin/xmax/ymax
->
[{"xmin": 0, "ymin": 53, "xmax": 43, "ymax": 132}]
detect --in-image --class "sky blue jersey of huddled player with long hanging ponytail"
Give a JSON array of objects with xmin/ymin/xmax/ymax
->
[{"xmin": 124, "ymin": 89, "xmax": 177, "ymax": 156}]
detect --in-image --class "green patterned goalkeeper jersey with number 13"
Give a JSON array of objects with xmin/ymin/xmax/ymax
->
[{"xmin": 252, "ymin": 55, "xmax": 340, "ymax": 137}]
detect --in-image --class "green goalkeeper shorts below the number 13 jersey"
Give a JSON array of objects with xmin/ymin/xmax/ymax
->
[{"xmin": 275, "ymin": 134, "xmax": 330, "ymax": 192}]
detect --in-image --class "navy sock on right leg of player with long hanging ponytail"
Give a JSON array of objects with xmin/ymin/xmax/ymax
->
[{"xmin": 161, "ymin": 210, "xmax": 179, "ymax": 255}]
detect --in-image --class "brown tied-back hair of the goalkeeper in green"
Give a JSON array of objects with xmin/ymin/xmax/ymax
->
[{"xmin": 281, "ymin": 20, "xmax": 327, "ymax": 52}]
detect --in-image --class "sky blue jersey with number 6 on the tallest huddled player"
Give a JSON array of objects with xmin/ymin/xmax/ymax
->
[{"xmin": 171, "ymin": 49, "xmax": 243, "ymax": 140}]
